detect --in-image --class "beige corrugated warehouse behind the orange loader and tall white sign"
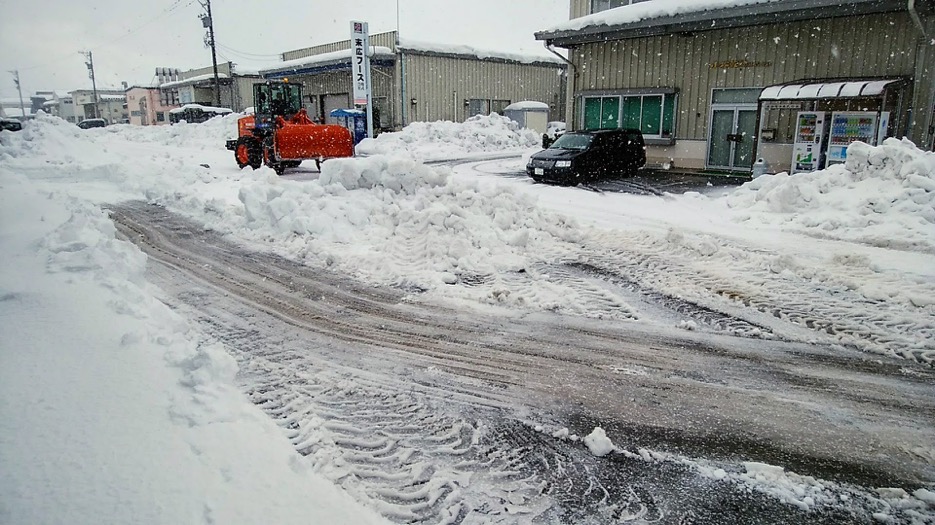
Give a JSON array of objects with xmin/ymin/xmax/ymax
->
[{"xmin": 260, "ymin": 31, "xmax": 566, "ymax": 129}]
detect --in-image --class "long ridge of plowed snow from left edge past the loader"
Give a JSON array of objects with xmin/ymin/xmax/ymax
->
[{"xmin": 0, "ymin": 117, "xmax": 632, "ymax": 318}]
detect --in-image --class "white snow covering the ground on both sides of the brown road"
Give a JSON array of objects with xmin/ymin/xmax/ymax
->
[{"xmin": 0, "ymin": 115, "xmax": 935, "ymax": 523}]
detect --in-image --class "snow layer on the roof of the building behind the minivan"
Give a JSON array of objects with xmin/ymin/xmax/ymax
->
[{"xmin": 542, "ymin": 0, "xmax": 784, "ymax": 33}]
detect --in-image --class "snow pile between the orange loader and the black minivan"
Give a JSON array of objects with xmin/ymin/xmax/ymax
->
[{"xmin": 357, "ymin": 113, "xmax": 541, "ymax": 160}]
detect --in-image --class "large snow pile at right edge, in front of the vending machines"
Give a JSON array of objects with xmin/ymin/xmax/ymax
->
[{"xmin": 727, "ymin": 138, "xmax": 935, "ymax": 251}]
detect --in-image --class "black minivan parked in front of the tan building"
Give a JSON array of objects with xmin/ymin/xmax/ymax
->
[{"xmin": 526, "ymin": 129, "xmax": 646, "ymax": 184}]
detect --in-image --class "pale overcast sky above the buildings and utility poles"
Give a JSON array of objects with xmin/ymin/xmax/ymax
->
[{"xmin": 0, "ymin": 0, "xmax": 568, "ymax": 98}]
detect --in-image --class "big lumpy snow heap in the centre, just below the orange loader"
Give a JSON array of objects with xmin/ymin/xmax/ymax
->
[{"xmin": 232, "ymin": 155, "xmax": 582, "ymax": 304}]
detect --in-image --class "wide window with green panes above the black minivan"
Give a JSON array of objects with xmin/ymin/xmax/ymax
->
[{"xmin": 584, "ymin": 93, "xmax": 676, "ymax": 138}]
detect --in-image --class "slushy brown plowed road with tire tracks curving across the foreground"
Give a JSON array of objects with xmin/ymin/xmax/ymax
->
[{"xmin": 111, "ymin": 199, "xmax": 935, "ymax": 524}]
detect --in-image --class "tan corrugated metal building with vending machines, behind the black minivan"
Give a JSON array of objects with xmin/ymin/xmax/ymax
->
[{"xmin": 536, "ymin": 0, "xmax": 935, "ymax": 173}]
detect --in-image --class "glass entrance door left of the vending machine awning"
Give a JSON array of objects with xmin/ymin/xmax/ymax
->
[{"xmin": 708, "ymin": 106, "xmax": 756, "ymax": 170}]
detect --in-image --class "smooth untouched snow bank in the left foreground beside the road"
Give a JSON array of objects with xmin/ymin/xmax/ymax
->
[{"xmin": 0, "ymin": 176, "xmax": 386, "ymax": 524}]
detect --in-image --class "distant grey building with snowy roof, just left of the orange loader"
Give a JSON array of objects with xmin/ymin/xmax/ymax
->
[{"xmin": 157, "ymin": 62, "xmax": 261, "ymax": 112}]
